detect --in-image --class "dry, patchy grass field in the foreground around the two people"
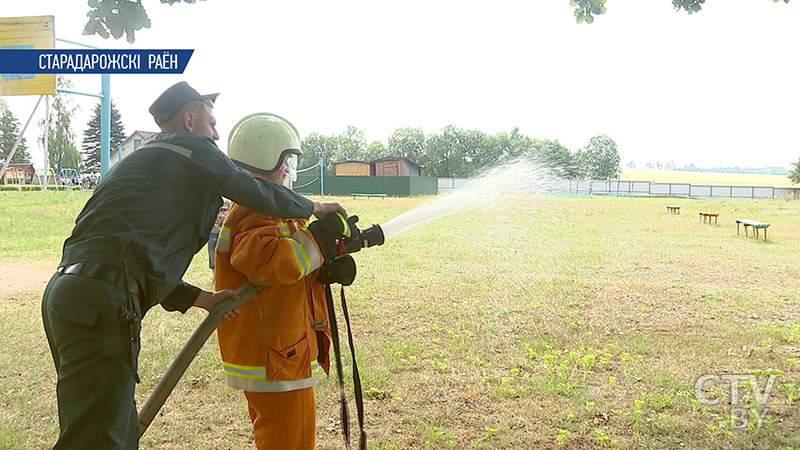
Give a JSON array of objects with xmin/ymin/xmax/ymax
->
[{"xmin": 0, "ymin": 193, "xmax": 800, "ymax": 450}]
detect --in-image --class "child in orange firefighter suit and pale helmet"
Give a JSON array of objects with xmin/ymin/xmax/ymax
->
[{"xmin": 214, "ymin": 113, "xmax": 346, "ymax": 450}]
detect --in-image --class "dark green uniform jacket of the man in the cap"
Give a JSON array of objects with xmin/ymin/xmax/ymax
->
[{"xmin": 61, "ymin": 132, "xmax": 313, "ymax": 312}]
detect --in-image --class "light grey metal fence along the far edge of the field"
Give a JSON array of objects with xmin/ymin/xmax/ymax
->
[{"xmin": 439, "ymin": 178, "xmax": 800, "ymax": 199}]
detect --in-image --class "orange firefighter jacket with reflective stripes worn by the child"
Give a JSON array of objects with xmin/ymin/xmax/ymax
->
[{"xmin": 214, "ymin": 203, "xmax": 330, "ymax": 392}]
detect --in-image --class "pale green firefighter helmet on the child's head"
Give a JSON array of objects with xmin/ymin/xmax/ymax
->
[{"xmin": 228, "ymin": 113, "xmax": 303, "ymax": 173}]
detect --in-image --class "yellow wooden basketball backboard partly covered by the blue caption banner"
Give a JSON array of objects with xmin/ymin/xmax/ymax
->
[{"xmin": 0, "ymin": 16, "xmax": 56, "ymax": 96}]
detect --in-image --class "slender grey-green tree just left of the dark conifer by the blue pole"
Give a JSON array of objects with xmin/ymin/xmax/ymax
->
[{"xmin": 39, "ymin": 76, "xmax": 81, "ymax": 173}]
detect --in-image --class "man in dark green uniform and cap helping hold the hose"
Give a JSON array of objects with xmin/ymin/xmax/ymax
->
[{"xmin": 42, "ymin": 82, "xmax": 344, "ymax": 449}]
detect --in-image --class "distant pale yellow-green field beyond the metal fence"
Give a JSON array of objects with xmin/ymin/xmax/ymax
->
[{"xmin": 621, "ymin": 169, "xmax": 798, "ymax": 188}]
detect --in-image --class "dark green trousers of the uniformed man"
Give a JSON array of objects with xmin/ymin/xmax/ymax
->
[{"xmin": 42, "ymin": 273, "xmax": 141, "ymax": 449}]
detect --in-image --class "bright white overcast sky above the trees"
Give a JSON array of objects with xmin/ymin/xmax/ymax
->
[{"xmin": 0, "ymin": 0, "xmax": 800, "ymax": 168}]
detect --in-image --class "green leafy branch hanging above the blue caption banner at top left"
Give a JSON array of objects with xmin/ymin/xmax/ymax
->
[{"xmin": 83, "ymin": 0, "xmax": 203, "ymax": 44}]
